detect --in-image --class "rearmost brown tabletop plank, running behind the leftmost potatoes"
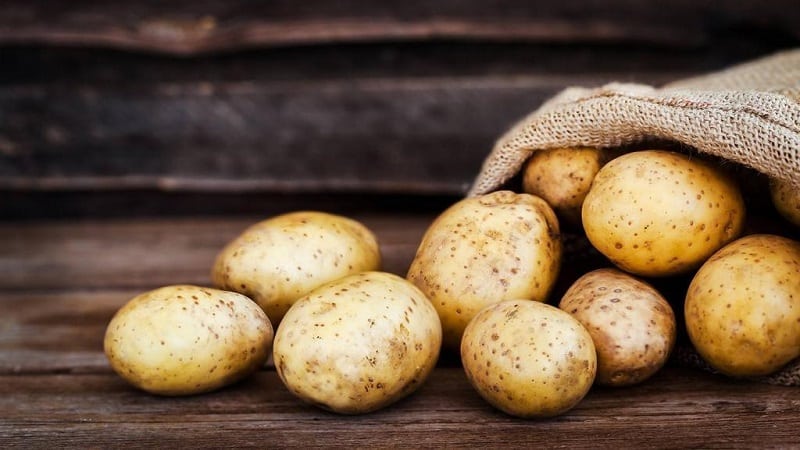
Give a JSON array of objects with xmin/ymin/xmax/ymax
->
[{"xmin": 0, "ymin": 212, "xmax": 433, "ymax": 295}]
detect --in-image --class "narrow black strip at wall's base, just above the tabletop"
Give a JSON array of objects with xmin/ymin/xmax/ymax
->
[{"xmin": 0, "ymin": 189, "xmax": 461, "ymax": 222}]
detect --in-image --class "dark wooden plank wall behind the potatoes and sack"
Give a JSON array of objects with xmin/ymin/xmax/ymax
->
[{"xmin": 0, "ymin": 0, "xmax": 800, "ymax": 219}]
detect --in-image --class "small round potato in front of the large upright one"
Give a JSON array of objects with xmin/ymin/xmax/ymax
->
[{"xmin": 461, "ymin": 300, "xmax": 597, "ymax": 418}]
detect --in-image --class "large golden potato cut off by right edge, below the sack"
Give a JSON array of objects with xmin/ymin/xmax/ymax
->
[{"xmin": 684, "ymin": 234, "xmax": 800, "ymax": 376}]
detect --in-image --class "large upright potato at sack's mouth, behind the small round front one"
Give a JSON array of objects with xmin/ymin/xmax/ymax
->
[{"xmin": 407, "ymin": 191, "xmax": 562, "ymax": 350}]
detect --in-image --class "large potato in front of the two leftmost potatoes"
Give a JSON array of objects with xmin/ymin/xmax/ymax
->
[{"xmin": 273, "ymin": 272, "xmax": 442, "ymax": 414}]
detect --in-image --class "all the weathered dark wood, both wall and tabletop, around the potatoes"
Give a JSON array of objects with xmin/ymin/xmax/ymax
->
[{"xmin": 0, "ymin": 0, "xmax": 800, "ymax": 448}]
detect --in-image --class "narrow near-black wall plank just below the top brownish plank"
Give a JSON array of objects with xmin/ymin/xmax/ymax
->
[{"xmin": 0, "ymin": 40, "xmax": 764, "ymax": 88}]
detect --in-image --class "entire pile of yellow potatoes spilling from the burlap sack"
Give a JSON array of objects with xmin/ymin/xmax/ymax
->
[{"xmin": 104, "ymin": 148, "xmax": 800, "ymax": 417}]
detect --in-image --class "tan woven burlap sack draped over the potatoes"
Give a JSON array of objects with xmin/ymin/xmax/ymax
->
[{"xmin": 468, "ymin": 49, "xmax": 800, "ymax": 385}]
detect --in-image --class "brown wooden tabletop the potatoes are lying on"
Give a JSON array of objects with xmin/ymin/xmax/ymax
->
[{"xmin": 0, "ymin": 213, "xmax": 800, "ymax": 448}]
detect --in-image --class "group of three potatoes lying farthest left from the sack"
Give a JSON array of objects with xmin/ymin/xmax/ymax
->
[{"xmin": 104, "ymin": 211, "xmax": 442, "ymax": 414}]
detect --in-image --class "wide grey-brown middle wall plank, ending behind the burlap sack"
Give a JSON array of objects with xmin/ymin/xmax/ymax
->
[{"xmin": 0, "ymin": 75, "xmax": 664, "ymax": 194}]
